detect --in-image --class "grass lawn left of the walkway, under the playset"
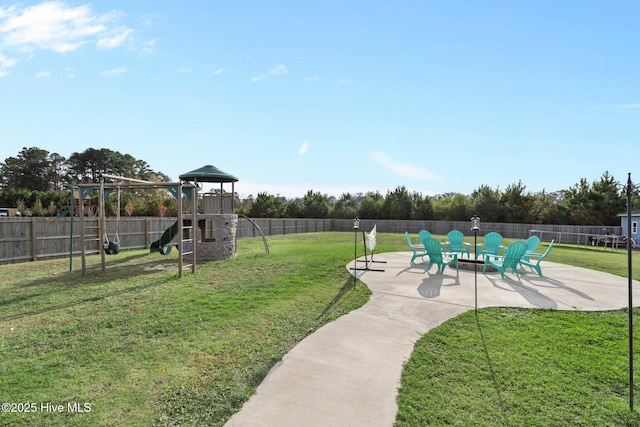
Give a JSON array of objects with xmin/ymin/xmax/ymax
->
[{"xmin": 0, "ymin": 233, "xmax": 369, "ymax": 426}]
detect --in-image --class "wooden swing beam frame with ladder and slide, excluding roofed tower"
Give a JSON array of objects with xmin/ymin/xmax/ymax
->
[{"xmin": 70, "ymin": 174, "xmax": 198, "ymax": 277}]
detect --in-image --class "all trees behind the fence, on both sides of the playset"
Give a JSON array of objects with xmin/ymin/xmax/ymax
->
[{"xmin": 0, "ymin": 147, "xmax": 640, "ymax": 226}]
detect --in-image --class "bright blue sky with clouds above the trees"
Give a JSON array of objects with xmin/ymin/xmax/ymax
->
[{"xmin": 0, "ymin": 0, "xmax": 640, "ymax": 197}]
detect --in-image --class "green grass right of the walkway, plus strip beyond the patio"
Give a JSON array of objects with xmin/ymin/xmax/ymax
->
[{"xmin": 396, "ymin": 236, "xmax": 640, "ymax": 427}]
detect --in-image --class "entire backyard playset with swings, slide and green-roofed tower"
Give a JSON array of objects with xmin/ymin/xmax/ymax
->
[{"xmin": 70, "ymin": 165, "xmax": 269, "ymax": 277}]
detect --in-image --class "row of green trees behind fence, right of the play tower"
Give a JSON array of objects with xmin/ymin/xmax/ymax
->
[{"xmin": 240, "ymin": 171, "xmax": 640, "ymax": 226}]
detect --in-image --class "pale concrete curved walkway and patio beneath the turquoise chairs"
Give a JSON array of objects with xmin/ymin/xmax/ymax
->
[{"xmin": 226, "ymin": 252, "xmax": 640, "ymax": 427}]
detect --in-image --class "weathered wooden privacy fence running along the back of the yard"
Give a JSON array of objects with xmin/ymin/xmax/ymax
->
[{"xmin": 0, "ymin": 217, "xmax": 622, "ymax": 263}]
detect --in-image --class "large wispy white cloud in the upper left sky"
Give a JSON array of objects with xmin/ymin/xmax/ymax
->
[{"xmin": 0, "ymin": 1, "xmax": 133, "ymax": 53}]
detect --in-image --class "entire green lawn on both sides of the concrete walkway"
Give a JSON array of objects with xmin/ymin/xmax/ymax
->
[{"xmin": 0, "ymin": 233, "xmax": 640, "ymax": 426}]
